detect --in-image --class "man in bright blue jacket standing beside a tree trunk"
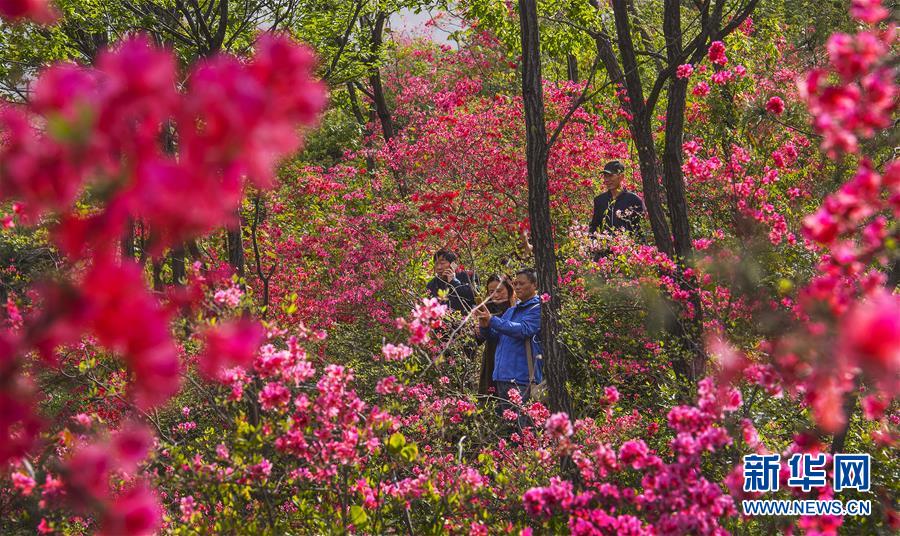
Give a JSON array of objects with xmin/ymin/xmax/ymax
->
[{"xmin": 475, "ymin": 268, "xmax": 543, "ymax": 427}]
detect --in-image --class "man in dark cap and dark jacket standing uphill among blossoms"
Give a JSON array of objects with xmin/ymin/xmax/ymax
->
[{"xmin": 589, "ymin": 160, "xmax": 644, "ymax": 239}]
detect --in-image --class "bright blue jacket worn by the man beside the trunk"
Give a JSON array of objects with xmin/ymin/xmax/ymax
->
[{"xmin": 481, "ymin": 296, "xmax": 543, "ymax": 385}]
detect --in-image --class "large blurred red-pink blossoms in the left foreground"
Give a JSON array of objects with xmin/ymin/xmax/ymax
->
[{"xmin": 0, "ymin": 26, "xmax": 324, "ymax": 533}]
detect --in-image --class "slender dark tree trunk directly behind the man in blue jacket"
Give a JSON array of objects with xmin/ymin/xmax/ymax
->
[{"xmin": 519, "ymin": 0, "xmax": 572, "ymax": 415}]
